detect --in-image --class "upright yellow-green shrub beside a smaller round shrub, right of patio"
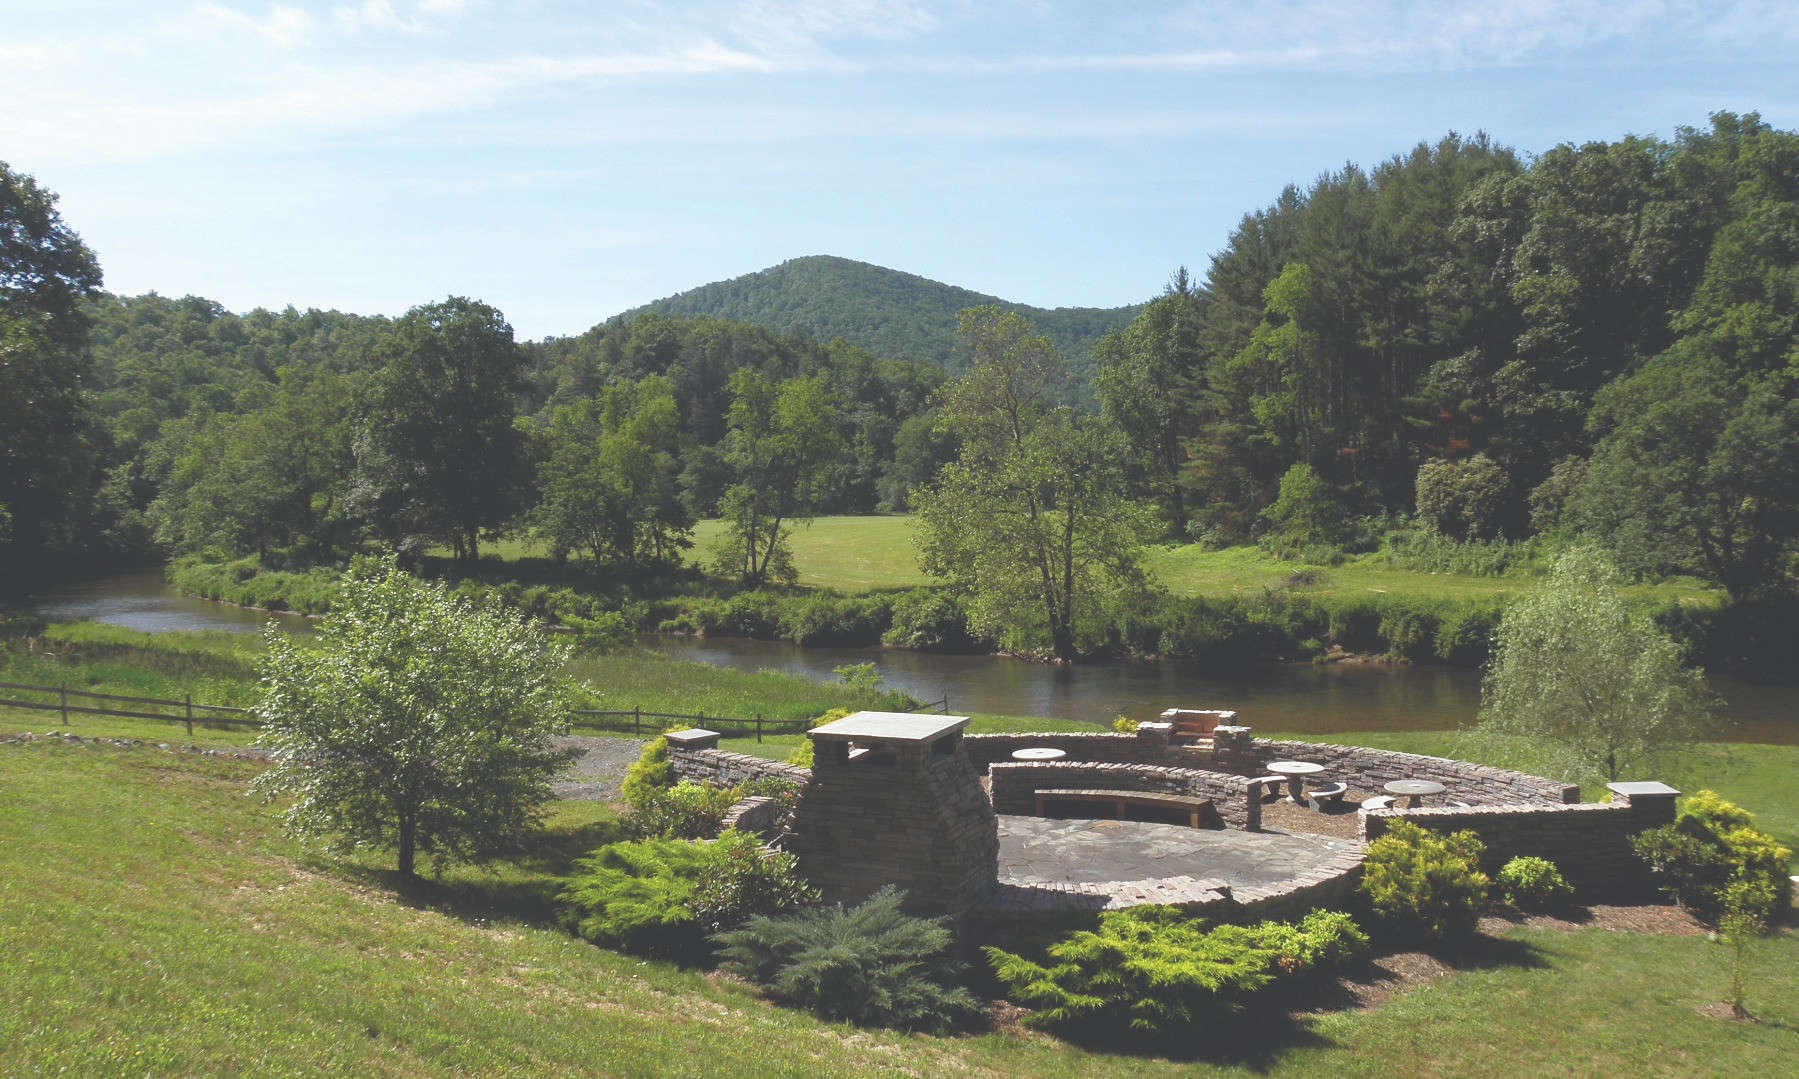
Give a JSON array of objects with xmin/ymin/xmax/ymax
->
[{"xmin": 1362, "ymin": 820, "xmax": 1490, "ymax": 939}]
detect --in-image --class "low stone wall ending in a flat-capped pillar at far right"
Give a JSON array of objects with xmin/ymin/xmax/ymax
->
[{"xmin": 1362, "ymin": 784, "xmax": 1678, "ymax": 901}]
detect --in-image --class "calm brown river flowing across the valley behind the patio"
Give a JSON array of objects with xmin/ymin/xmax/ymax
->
[{"xmin": 31, "ymin": 574, "xmax": 1799, "ymax": 745}]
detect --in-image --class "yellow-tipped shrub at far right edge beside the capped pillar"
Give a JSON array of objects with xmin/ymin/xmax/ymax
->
[{"xmin": 1632, "ymin": 791, "xmax": 1794, "ymax": 923}]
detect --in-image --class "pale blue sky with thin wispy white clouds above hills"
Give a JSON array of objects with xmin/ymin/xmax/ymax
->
[{"xmin": 10, "ymin": 0, "xmax": 1799, "ymax": 336}]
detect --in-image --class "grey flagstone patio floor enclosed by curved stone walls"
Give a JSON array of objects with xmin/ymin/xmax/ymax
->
[{"xmin": 1000, "ymin": 815, "xmax": 1362, "ymax": 899}]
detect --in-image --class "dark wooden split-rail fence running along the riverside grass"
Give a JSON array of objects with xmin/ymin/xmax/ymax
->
[{"xmin": 0, "ymin": 682, "xmax": 950, "ymax": 741}]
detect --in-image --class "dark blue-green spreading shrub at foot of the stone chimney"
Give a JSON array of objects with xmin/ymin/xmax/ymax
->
[{"xmin": 712, "ymin": 887, "xmax": 975, "ymax": 1030}]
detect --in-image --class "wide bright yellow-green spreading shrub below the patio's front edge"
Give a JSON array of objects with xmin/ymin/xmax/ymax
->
[{"xmin": 986, "ymin": 906, "xmax": 1367, "ymax": 1038}]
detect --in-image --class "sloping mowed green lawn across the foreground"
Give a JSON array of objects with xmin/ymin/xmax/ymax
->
[{"xmin": 0, "ymin": 745, "xmax": 1799, "ymax": 1079}]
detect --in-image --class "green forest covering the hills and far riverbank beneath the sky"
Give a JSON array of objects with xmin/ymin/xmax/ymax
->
[{"xmin": 0, "ymin": 113, "xmax": 1799, "ymax": 671}]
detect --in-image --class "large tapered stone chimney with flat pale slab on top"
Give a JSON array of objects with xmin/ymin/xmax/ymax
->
[{"xmin": 786, "ymin": 712, "xmax": 1000, "ymax": 914}]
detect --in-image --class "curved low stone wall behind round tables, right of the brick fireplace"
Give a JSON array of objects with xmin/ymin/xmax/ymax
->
[{"xmin": 1213, "ymin": 728, "xmax": 1580, "ymax": 806}]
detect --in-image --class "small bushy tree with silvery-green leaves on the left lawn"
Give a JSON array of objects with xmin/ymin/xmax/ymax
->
[{"xmin": 254, "ymin": 563, "xmax": 568, "ymax": 878}]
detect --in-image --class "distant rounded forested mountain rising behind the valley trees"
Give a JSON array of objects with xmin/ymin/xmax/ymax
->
[{"xmin": 622, "ymin": 255, "xmax": 1142, "ymax": 387}]
